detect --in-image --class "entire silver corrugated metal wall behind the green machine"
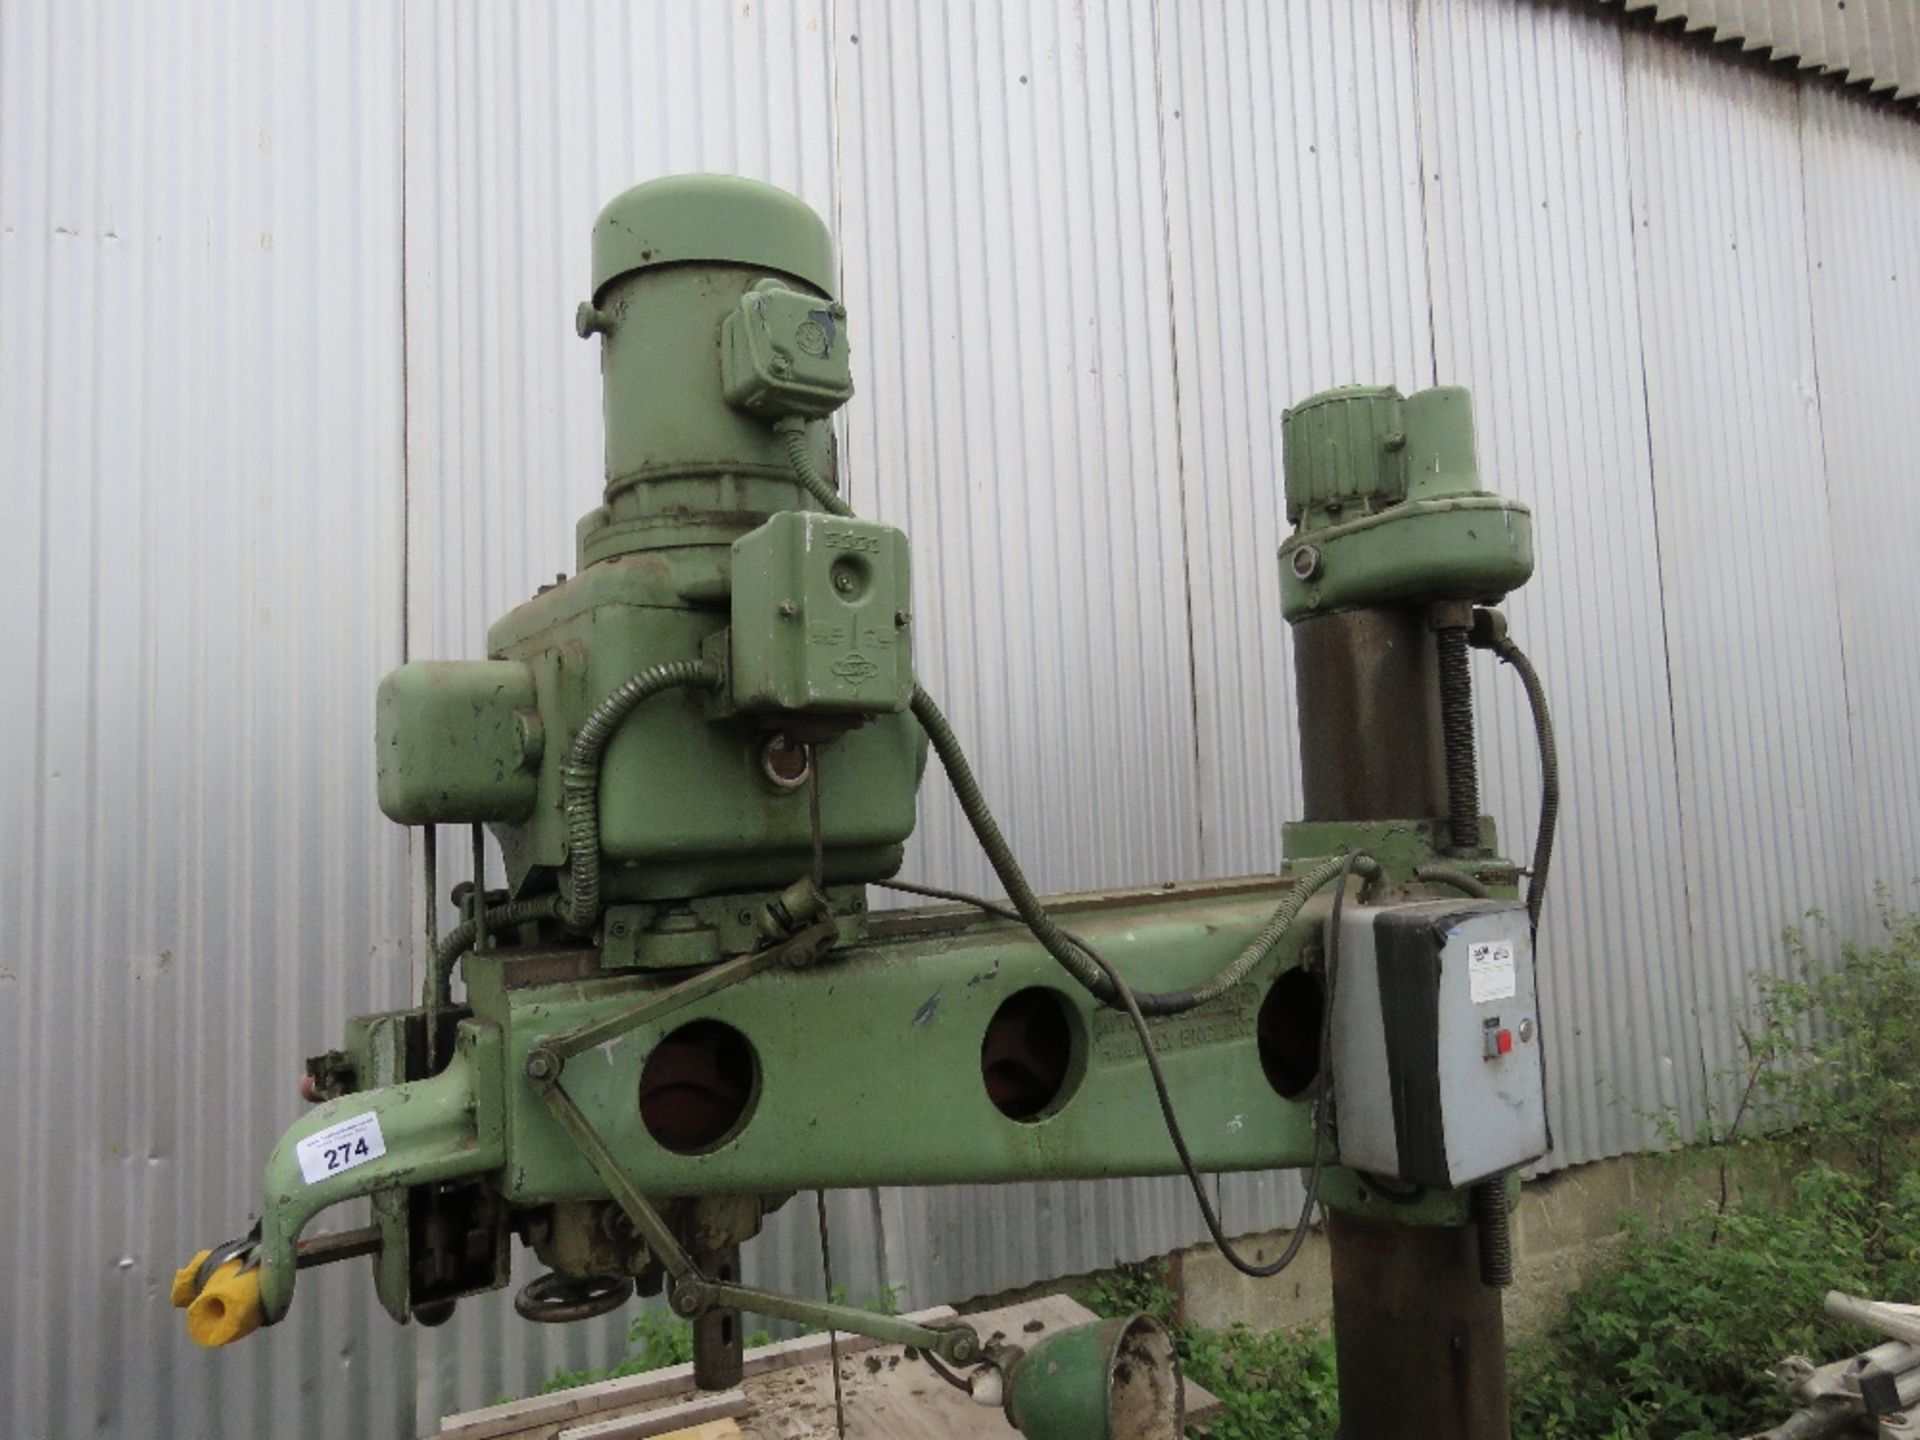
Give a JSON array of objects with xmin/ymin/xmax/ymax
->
[{"xmin": 11, "ymin": 0, "xmax": 1920, "ymax": 1436}]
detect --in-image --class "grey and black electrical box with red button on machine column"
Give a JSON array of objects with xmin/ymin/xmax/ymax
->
[{"xmin": 1332, "ymin": 900, "xmax": 1548, "ymax": 1190}]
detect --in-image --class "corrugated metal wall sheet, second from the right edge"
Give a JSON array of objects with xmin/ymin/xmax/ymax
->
[{"xmin": 1626, "ymin": 35, "xmax": 1873, "ymax": 1112}]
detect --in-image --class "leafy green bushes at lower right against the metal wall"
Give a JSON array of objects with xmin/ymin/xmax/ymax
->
[{"xmin": 1513, "ymin": 902, "xmax": 1920, "ymax": 1440}]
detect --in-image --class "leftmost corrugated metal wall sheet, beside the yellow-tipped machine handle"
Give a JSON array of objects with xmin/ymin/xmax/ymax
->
[{"xmin": 0, "ymin": 0, "xmax": 413, "ymax": 1440}]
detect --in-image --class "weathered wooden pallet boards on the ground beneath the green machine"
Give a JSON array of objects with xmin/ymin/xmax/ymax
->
[{"xmin": 426, "ymin": 1294, "xmax": 1219, "ymax": 1440}]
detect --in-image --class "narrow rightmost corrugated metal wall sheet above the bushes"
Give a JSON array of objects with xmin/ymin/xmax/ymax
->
[{"xmin": 1801, "ymin": 90, "xmax": 1920, "ymax": 908}]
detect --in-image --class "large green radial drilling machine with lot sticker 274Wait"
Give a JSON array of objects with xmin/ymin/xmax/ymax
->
[{"xmin": 175, "ymin": 177, "xmax": 1551, "ymax": 1436}]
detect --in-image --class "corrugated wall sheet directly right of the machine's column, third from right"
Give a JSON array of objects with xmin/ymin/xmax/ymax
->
[{"xmin": 1419, "ymin": 0, "xmax": 1699, "ymax": 1165}]
